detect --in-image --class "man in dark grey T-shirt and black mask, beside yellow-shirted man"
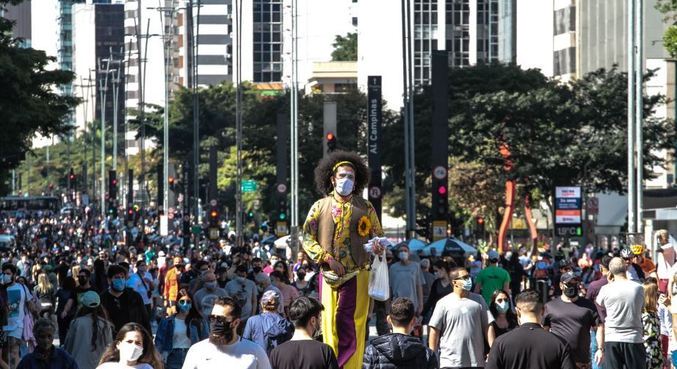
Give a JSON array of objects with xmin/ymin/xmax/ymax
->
[{"xmin": 543, "ymin": 272, "xmax": 604, "ymax": 368}]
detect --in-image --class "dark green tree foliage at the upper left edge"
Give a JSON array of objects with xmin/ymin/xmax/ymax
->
[{"xmin": 0, "ymin": 0, "xmax": 78, "ymax": 191}]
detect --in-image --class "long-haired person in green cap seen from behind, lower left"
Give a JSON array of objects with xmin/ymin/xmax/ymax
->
[{"xmin": 63, "ymin": 291, "xmax": 115, "ymax": 369}]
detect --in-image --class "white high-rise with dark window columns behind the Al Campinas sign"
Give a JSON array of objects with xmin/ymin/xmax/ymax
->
[{"xmin": 357, "ymin": 0, "xmax": 514, "ymax": 108}]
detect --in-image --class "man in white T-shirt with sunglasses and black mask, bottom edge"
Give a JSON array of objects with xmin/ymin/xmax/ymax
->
[{"xmin": 182, "ymin": 297, "xmax": 270, "ymax": 369}]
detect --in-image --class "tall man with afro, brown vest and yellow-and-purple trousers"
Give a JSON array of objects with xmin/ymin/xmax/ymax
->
[{"xmin": 303, "ymin": 151, "xmax": 383, "ymax": 369}]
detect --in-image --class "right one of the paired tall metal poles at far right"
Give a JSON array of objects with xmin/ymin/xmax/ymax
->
[{"xmin": 634, "ymin": 0, "xmax": 644, "ymax": 233}]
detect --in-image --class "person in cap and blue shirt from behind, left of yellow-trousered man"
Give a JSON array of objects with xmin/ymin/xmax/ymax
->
[{"xmin": 242, "ymin": 291, "xmax": 294, "ymax": 354}]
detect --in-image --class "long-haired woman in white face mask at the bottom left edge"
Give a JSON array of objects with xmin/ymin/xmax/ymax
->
[{"xmin": 97, "ymin": 323, "xmax": 163, "ymax": 369}]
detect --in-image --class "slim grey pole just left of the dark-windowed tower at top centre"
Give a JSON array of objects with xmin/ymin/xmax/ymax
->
[{"xmin": 235, "ymin": 0, "xmax": 244, "ymax": 246}]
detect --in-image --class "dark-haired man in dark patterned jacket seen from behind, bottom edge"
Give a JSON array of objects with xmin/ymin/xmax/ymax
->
[{"xmin": 362, "ymin": 297, "xmax": 438, "ymax": 369}]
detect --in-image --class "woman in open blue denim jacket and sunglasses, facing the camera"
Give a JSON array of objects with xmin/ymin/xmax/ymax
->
[{"xmin": 155, "ymin": 290, "xmax": 209, "ymax": 369}]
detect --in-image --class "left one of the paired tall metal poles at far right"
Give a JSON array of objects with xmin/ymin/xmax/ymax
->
[{"xmin": 627, "ymin": 0, "xmax": 637, "ymax": 233}]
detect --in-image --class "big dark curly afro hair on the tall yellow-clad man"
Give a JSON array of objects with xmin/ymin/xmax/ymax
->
[{"xmin": 315, "ymin": 151, "xmax": 369, "ymax": 196}]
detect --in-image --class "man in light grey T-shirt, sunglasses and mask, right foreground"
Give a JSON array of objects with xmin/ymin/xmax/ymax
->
[{"xmin": 428, "ymin": 267, "xmax": 494, "ymax": 368}]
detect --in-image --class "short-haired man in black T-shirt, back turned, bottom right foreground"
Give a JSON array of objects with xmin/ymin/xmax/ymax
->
[{"xmin": 485, "ymin": 291, "xmax": 576, "ymax": 369}]
